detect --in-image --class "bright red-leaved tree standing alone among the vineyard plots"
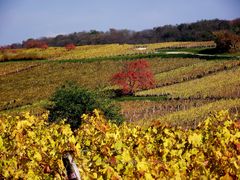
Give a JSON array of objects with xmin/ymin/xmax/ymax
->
[{"xmin": 111, "ymin": 60, "xmax": 155, "ymax": 94}]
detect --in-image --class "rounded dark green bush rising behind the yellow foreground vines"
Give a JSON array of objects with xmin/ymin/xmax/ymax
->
[{"xmin": 47, "ymin": 83, "xmax": 123, "ymax": 129}]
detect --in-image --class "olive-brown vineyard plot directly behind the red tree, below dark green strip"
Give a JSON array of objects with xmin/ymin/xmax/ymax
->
[{"xmin": 0, "ymin": 58, "xmax": 201, "ymax": 109}]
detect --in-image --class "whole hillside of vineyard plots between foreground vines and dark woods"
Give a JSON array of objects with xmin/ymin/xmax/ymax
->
[{"xmin": 0, "ymin": 42, "xmax": 240, "ymax": 127}]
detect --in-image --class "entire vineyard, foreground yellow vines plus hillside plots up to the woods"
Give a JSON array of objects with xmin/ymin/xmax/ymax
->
[{"xmin": 0, "ymin": 42, "xmax": 240, "ymax": 179}]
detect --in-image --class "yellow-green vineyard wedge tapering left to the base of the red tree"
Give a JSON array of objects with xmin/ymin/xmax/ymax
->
[{"xmin": 135, "ymin": 67, "xmax": 240, "ymax": 98}]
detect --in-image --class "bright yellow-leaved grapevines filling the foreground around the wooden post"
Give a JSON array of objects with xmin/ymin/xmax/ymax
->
[{"xmin": 0, "ymin": 110, "xmax": 240, "ymax": 179}]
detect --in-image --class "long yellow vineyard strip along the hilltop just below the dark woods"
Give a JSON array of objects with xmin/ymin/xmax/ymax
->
[{"xmin": 0, "ymin": 41, "xmax": 215, "ymax": 61}]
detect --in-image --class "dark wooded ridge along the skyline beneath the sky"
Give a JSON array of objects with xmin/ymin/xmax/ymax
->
[{"xmin": 11, "ymin": 18, "xmax": 240, "ymax": 48}]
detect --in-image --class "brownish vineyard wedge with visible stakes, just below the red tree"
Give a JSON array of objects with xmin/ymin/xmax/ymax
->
[{"xmin": 119, "ymin": 99, "xmax": 214, "ymax": 125}]
